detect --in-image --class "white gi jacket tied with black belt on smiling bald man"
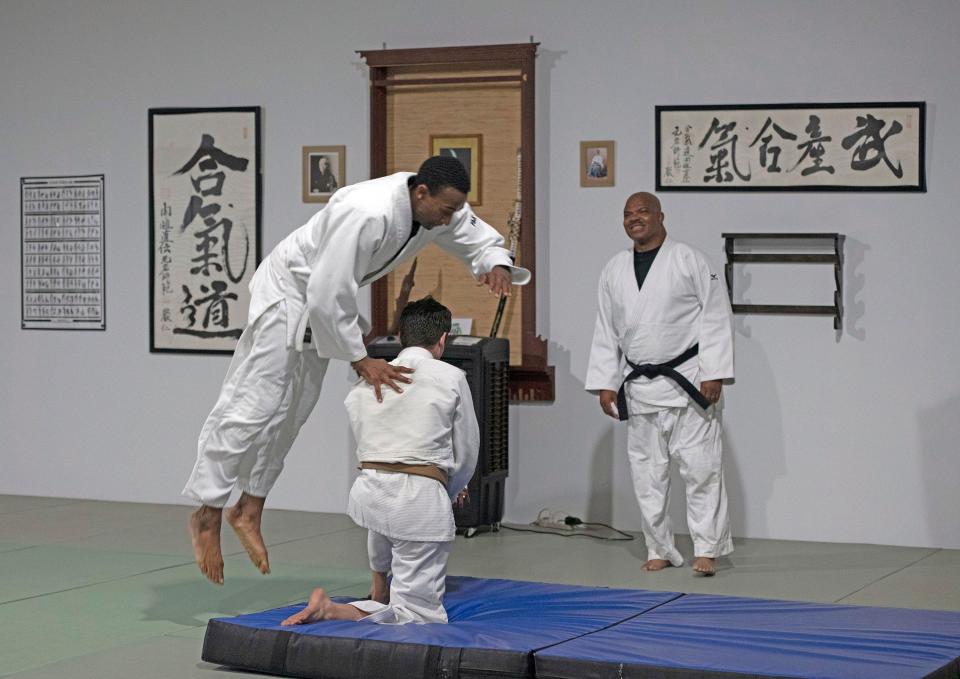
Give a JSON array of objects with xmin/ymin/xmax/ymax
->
[{"xmin": 585, "ymin": 236, "xmax": 733, "ymax": 414}]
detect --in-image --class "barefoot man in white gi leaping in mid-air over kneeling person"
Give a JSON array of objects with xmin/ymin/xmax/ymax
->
[{"xmin": 183, "ymin": 156, "xmax": 530, "ymax": 584}]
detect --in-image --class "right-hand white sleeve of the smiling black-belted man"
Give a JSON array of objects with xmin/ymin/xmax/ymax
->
[{"xmin": 694, "ymin": 257, "xmax": 733, "ymax": 381}]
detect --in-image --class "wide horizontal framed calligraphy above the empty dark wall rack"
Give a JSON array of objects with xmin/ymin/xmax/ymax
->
[{"xmin": 656, "ymin": 102, "xmax": 927, "ymax": 191}]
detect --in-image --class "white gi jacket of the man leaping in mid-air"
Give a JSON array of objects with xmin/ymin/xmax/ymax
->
[{"xmin": 248, "ymin": 172, "xmax": 530, "ymax": 361}]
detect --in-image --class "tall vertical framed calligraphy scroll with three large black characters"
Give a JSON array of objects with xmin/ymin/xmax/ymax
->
[{"xmin": 149, "ymin": 107, "xmax": 261, "ymax": 353}]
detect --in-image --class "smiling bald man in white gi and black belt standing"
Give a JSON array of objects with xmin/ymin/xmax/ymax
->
[{"xmin": 586, "ymin": 193, "xmax": 733, "ymax": 575}]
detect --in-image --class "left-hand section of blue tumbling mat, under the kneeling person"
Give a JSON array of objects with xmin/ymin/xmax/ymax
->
[{"xmin": 203, "ymin": 577, "xmax": 681, "ymax": 679}]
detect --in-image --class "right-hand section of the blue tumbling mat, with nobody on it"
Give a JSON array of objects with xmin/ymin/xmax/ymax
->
[{"xmin": 536, "ymin": 594, "xmax": 960, "ymax": 679}]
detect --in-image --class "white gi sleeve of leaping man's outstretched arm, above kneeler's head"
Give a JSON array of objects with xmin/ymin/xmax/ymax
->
[{"xmin": 434, "ymin": 205, "xmax": 530, "ymax": 285}]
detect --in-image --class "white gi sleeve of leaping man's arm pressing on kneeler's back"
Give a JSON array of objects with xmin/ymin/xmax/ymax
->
[{"xmin": 307, "ymin": 208, "xmax": 386, "ymax": 361}]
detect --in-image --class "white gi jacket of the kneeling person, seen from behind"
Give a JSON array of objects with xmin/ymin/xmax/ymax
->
[{"xmin": 344, "ymin": 347, "xmax": 480, "ymax": 542}]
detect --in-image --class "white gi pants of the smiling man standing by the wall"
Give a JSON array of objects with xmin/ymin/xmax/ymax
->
[{"xmin": 627, "ymin": 403, "xmax": 733, "ymax": 566}]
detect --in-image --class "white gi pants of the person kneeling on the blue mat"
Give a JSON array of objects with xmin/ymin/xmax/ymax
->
[{"xmin": 350, "ymin": 530, "xmax": 453, "ymax": 625}]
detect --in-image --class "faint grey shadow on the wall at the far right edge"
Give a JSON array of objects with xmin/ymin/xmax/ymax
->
[{"xmin": 916, "ymin": 395, "xmax": 960, "ymax": 549}]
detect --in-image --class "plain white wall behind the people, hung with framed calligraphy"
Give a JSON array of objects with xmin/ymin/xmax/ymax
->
[{"xmin": 0, "ymin": 0, "xmax": 960, "ymax": 548}]
